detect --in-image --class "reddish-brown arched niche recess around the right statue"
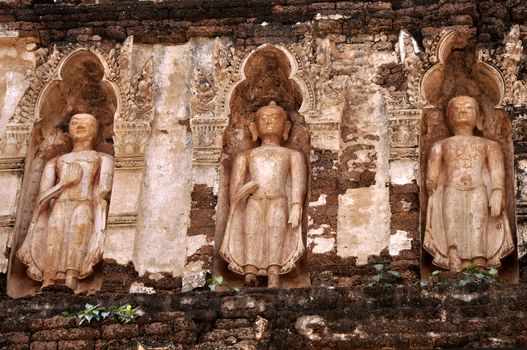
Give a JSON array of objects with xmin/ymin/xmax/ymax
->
[{"xmin": 419, "ymin": 32, "xmax": 518, "ymax": 282}]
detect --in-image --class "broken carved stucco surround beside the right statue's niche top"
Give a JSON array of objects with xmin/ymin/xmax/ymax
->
[{"xmin": 385, "ymin": 26, "xmax": 516, "ymax": 163}]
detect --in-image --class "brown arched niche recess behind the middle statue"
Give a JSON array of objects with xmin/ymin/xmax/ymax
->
[{"xmin": 213, "ymin": 45, "xmax": 311, "ymax": 288}]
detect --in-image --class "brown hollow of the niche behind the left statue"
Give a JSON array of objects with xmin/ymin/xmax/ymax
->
[{"xmin": 7, "ymin": 50, "xmax": 117, "ymax": 295}]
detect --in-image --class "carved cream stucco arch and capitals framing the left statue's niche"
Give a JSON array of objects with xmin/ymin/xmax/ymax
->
[{"xmin": 0, "ymin": 37, "xmax": 153, "ymax": 165}]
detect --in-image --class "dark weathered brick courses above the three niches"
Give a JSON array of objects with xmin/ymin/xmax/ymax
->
[{"xmin": 0, "ymin": 0, "xmax": 527, "ymax": 46}]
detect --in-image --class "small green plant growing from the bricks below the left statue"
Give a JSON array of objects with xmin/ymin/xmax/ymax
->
[{"xmin": 60, "ymin": 304, "xmax": 144, "ymax": 325}]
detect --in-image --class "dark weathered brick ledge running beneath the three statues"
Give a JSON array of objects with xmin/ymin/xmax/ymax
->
[{"xmin": 0, "ymin": 285, "xmax": 527, "ymax": 350}]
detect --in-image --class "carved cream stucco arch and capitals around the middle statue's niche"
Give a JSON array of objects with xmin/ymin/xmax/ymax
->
[{"xmin": 190, "ymin": 33, "xmax": 354, "ymax": 167}]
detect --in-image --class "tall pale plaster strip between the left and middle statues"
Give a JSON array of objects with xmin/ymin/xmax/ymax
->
[{"xmin": 134, "ymin": 44, "xmax": 192, "ymax": 275}]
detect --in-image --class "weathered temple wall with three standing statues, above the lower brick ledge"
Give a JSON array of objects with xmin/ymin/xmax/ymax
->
[{"xmin": 0, "ymin": 0, "xmax": 527, "ymax": 348}]
